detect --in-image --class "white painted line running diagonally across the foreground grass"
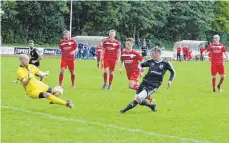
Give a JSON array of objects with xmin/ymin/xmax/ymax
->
[{"xmin": 1, "ymin": 105, "xmax": 212, "ymax": 143}]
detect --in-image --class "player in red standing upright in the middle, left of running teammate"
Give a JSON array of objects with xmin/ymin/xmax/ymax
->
[{"xmin": 101, "ymin": 30, "xmax": 121, "ymax": 89}]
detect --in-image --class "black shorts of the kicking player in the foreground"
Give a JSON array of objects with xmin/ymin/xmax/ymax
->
[{"xmin": 136, "ymin": 81, "xmax": 159, "ymax": 97}]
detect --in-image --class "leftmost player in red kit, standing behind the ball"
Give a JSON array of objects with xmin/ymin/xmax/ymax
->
[{"xmin": 59, "ymin": 30, "xmax": 77, "ymax": 88}]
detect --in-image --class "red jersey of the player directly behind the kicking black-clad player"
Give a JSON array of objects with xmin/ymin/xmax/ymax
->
[{"xmin": 121, "ymin": 50, "xmax": 143, "ymax": 74}]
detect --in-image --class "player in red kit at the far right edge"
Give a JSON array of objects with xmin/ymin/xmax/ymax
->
[{"xmin": 206, "ymin": 35, "xmax": 228, "ymax": 92}]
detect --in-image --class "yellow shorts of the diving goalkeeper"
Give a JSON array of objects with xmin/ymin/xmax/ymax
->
[{"xmin": 27, "ymin": 81, "xmax": 50, "ymax": 99}]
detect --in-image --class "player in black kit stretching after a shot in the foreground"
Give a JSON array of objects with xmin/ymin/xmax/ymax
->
[{"xmin": 119, "ymin": 48, "xmax": 175, "ymax": 114}]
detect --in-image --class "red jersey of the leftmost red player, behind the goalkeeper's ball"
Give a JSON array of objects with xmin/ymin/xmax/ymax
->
[{"xmin": 59, "ymin": 39, "xmax": 77, "ymax": 60}]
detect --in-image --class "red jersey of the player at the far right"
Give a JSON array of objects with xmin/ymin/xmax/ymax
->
[{"xmin": 206, "ymin": 43, "xmax": 227, "ymax": 64}]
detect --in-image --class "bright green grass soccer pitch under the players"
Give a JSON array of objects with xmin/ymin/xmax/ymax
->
[{"xmin": 1, "ymin": 58, "xmax": 229, "ymax": 143}]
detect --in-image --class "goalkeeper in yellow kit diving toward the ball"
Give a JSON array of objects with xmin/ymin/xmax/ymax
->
[{"xmin": 17, "ymin": 54, "xmax": 73, "ymax": 108}]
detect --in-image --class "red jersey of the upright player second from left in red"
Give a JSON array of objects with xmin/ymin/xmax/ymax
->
[{"xmin": 103, "ymin": 39, "xmax": 120, "ymax": 60}]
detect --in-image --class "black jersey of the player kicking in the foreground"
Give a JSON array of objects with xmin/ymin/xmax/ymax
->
[{"xmin": 140, "ymin": 60, "xmax": 175, "ymax": 87}]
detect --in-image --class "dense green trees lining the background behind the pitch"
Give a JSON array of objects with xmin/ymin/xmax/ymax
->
[{"xmin": 1, "ymin": 1, "xmax": 229, "ymax": 48}]
